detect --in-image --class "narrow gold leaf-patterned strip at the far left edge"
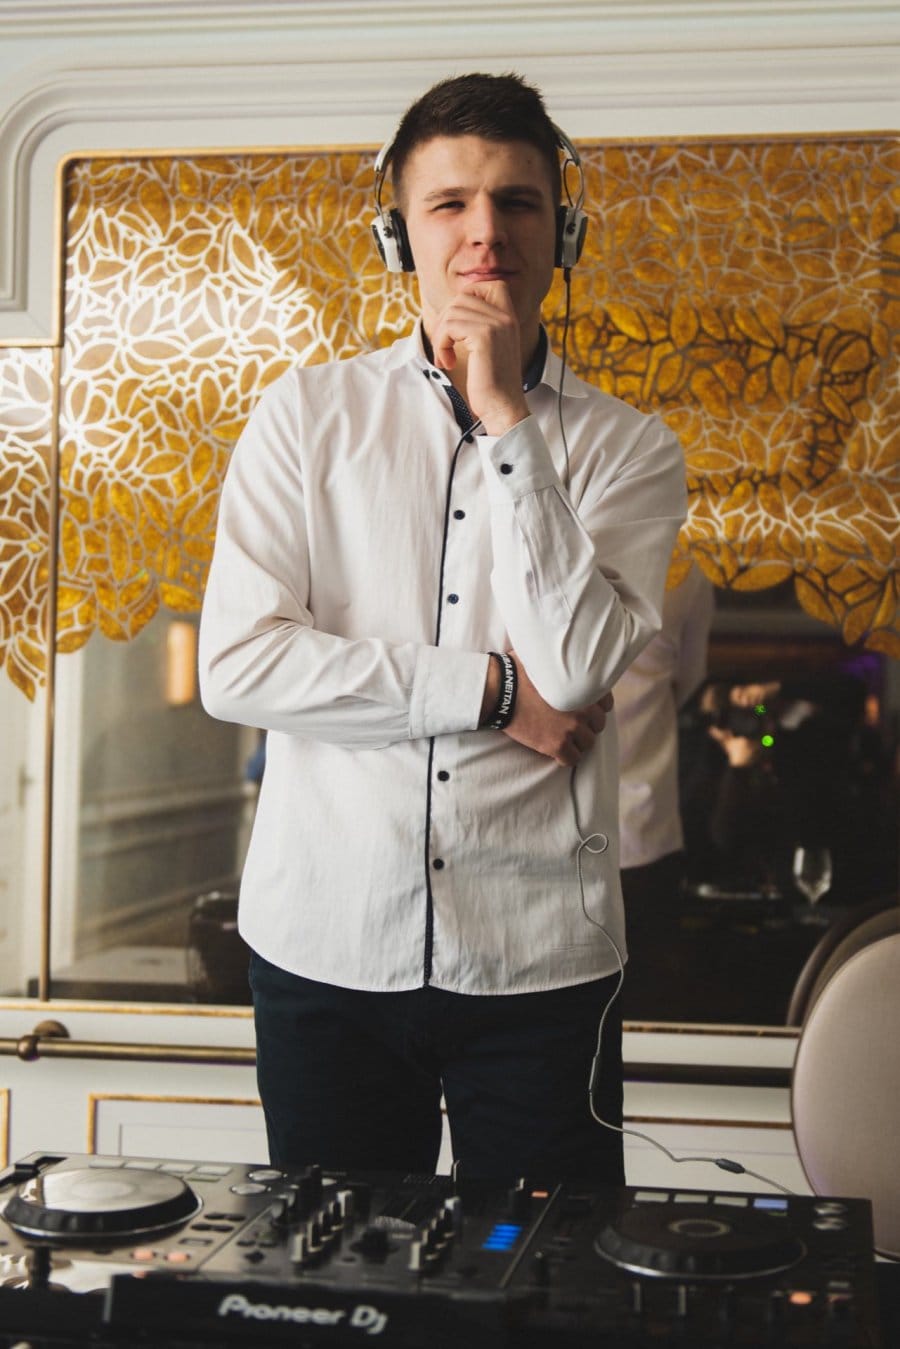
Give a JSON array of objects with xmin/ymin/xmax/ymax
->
[{"xmin": 0, "ymin": 342, "xmax": 54, "ymax": 699}]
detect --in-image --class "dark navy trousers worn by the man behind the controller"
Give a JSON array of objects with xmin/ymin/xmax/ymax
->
[{"xmin": 250, "ymin": 954, "xmax": 625, "ymax": 1184}]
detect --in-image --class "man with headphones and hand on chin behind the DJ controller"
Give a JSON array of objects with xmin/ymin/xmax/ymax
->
[{"xmin": 201, "ymin": 74, "xmax": 684, "ymax": 1182}]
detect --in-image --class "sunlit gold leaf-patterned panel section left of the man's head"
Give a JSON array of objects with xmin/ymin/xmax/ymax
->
[{"xmin": 58, "ymin": 152, "xmax": 413, "ymax": 650}]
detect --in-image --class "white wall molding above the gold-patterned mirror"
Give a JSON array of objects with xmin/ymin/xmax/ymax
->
[{"xmin": 0, "ymin": 0, "xmax": 900, "ymax": 345}]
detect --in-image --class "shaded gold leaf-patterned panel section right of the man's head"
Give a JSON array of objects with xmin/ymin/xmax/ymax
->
[{"xmin": 553, "ymin": 138, "xmax": 900, "ymax": 656}]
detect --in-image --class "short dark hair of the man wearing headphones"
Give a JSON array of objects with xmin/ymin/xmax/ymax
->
[{"xmin": 391, "ymin": 74, "xmax": 563, "ymax": 202}]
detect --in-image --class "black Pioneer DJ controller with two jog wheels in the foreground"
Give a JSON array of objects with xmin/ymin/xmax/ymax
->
[{"xmin": 0, "ymin": 1153, "xmax": 881, "ymax": 1349}]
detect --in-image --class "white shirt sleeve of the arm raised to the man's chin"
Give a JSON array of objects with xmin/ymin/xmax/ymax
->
[{"xmin": 482, "ymin": 418, "xmax": 684, "ymax": 710}]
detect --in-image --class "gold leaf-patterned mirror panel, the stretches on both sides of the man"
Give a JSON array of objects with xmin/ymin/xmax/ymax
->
[{"xmin": 0, "ymin": 136, "xmax": 900, "ymax": 696}]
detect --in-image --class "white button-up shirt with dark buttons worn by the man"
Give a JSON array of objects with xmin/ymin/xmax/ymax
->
[{"xmin": 200, "ymin": 331, "xmax": 685, "ymax": 993}]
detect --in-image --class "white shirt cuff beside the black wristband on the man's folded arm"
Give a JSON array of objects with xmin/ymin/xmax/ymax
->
[{"xmin": 409, "ymin": 646, "xmax": 490, "ymax": 739}]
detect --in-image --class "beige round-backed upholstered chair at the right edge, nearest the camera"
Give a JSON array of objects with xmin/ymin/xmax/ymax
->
[{"xmin": 791, "ymin": 932, "xmax": 900, "ymax": 1260}]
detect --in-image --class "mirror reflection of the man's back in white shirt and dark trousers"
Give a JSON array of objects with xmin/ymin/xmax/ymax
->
[{"xmin": 614, "ymin": 565, "xmax": 714, "ymax": 1017}]
